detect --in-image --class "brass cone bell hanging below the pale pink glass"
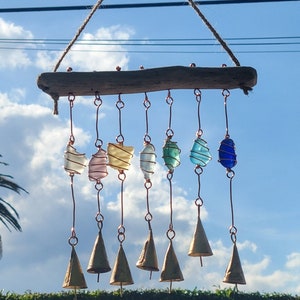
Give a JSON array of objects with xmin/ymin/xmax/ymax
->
[{"xmin": 87, "ymin": 230, "xmax": 111, "ymax": 275}]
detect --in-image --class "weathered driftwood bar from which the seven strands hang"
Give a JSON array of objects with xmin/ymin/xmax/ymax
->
[{"xmin": 37, "ymin": 66, "xmax": 257, "ymax": 100}]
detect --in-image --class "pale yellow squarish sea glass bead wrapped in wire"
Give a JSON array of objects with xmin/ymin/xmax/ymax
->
[{"xmin": 107, "ymin": 143, "xmax": 134, "ymax": 171}]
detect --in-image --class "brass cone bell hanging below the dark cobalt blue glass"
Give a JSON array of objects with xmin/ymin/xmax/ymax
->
[{"xmin": 223, "ymin": 243, "xmax": 246, "ymax": 284}]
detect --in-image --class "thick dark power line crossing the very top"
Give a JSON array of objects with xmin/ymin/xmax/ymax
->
[{"xmin": 0, "ymin": 0, "xmax": 300, "ymax": 13}]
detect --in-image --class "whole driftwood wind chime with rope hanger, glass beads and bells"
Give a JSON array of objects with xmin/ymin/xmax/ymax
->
[{"xmin": 37, "ymin": 0, "xmax": 257, "ymax": 294}]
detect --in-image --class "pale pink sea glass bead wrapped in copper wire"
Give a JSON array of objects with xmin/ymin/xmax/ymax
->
[{"xmin": 88, "ymin": 148, "xmax": 108, "ymax": 182}]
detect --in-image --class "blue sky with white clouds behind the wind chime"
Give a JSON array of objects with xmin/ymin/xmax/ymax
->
[{"xmin": 0, "ymin": 0, "xmax": 300, "ymax": 294}]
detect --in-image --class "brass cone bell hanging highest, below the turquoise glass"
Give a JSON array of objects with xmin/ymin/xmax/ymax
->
[{"xmin": 188, "ymin": 217, "xmax": 213, "ymax": 257}]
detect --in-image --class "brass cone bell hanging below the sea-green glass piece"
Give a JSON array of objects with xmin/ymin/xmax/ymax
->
[{"xmin": 159, "ymin": 241, "xmax": 184, "ymax": 282}]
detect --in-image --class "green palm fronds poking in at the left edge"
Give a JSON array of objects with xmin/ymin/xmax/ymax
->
[{"xmin": 0, "ymin": 154, "xmax": 27, "ymax": 259}]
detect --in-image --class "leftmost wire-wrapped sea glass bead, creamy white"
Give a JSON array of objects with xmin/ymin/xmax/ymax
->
[{"xmin": 64, "ymin": 144, "xmax": 88, "ymax": 174}]
